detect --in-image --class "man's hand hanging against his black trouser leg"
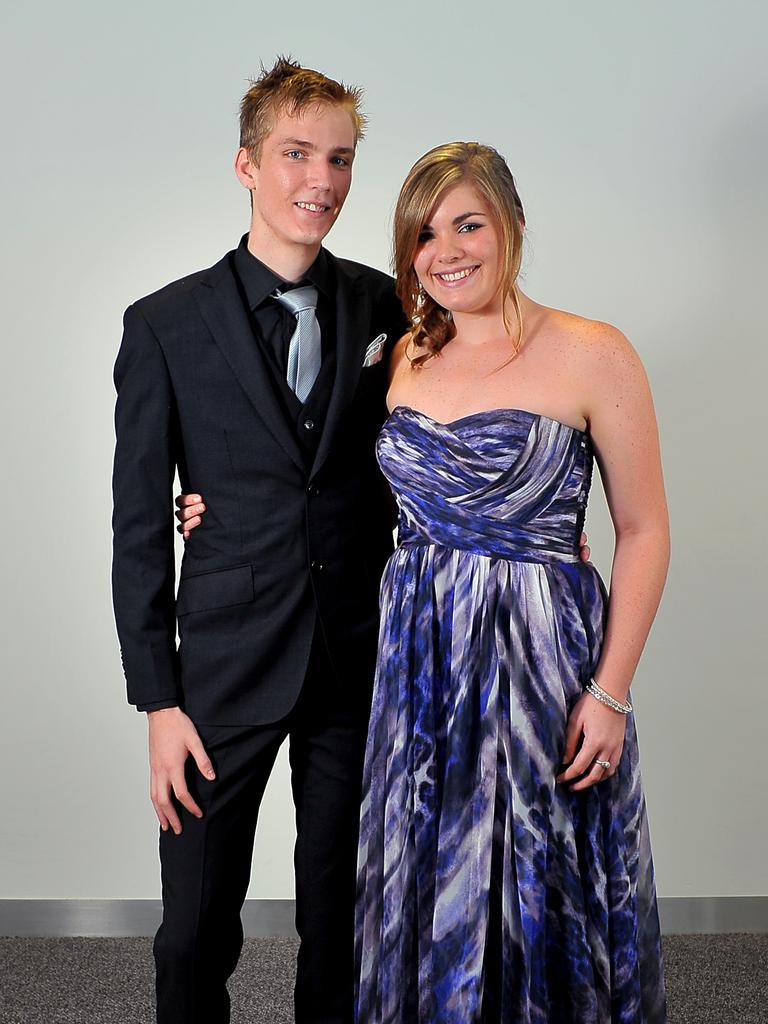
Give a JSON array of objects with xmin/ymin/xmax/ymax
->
[{"xmin": 146, "ymin": 708, "xmax": 216, "ymax": 836}]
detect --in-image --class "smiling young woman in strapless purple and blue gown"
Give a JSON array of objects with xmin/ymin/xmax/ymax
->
[{"xmin": 174, "ymin": 142, "xmax": 669, "ymax": 1024}]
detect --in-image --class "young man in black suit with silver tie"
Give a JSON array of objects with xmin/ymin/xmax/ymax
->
[{"xmin": 113, "ymin": 59, "xmax": 406, "ymax": 1024}]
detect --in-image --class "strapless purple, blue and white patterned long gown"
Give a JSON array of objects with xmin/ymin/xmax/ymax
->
[{"xmin": 355, "ymin": 406, "xmax": 666, "ymax": 1024}]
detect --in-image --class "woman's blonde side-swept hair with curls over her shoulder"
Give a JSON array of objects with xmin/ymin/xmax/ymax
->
[{"xmin": 392, "ymin": 142, "xmax": 525, "ymax": 367}]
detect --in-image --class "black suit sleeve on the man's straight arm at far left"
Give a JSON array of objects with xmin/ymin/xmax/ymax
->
[{"xmin": 112, "ymin": 306, "xmax": 180, "ymax": 710}]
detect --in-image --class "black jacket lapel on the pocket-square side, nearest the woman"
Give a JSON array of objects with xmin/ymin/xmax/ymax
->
[{"xmin": 311, "ymin": 260, "xmax": 371, "ymax": 476}]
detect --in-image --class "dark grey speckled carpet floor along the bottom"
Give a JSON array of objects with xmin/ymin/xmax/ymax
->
[{"xmin": 0, "ymin": 935, "xmax": 768, "ymax": 1024}]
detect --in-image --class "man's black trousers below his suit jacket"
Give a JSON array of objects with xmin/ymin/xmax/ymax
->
[{"xmin": 155, "ymin": 639, "xmax": 370, "ymax": 1024}]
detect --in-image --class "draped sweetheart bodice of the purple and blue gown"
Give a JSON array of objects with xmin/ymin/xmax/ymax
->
[{"xmin": 377, "ymin": 406, "xmax": 593, "ymax": 562}]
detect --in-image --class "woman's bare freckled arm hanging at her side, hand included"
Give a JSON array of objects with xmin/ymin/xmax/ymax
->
[{"xmin": 558, "ymin": 324, "xmax": 670, "ymax": 790}]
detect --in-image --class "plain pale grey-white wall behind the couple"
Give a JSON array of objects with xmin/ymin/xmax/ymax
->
[{"xmin": 0, "ymin": 0, "xmax": 768, "ymax": 898}]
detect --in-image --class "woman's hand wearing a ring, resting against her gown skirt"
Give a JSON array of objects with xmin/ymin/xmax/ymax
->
[{"xmin": 557, "ymin": 691, "xmax": 627, "ymax": 791}]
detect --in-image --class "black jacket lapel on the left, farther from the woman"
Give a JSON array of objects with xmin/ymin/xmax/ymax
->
[{"xmin": 195, "ymin": 256, "xmax": 306, "ymax": 470}]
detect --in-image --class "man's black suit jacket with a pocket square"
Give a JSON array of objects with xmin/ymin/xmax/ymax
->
[{"xmin": 113, "ymin": 245, "xmax": 406, "ymax": 725}]
